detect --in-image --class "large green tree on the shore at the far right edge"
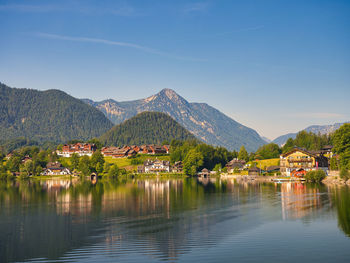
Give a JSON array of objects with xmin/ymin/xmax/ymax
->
[{"xmin": 332, "ymin": 123, "xmax": 350, "ymax": 169}]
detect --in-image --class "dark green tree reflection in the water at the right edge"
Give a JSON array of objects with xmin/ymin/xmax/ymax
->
[{"xmin": 330, "ymin": 186, "xmax": 350, "ymax": 237}]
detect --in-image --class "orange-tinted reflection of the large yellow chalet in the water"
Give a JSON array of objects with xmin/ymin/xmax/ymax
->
[{"xmin": 281, "ymin": 182, "xmax": 322, "ymax": 220}]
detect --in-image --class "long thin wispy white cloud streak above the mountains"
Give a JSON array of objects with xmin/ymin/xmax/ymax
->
[{"xmin": 34, "ymin": 32, "xmax": 206, "ymax": 61}]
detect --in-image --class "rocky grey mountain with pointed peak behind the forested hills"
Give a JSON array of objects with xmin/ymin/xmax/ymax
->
[{"xmin": 83, "ymin": 89, "xmax": 265, "ymax": 151}]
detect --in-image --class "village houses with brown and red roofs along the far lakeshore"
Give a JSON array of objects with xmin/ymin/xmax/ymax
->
[{"xmin": 6, "ymin": 142, "xmax": 334, "ymax": 183}]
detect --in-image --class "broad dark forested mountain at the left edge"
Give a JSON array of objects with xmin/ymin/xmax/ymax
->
[{"xmin": 0, "ymin": 83, "xmax": 113, "ymax": 142}]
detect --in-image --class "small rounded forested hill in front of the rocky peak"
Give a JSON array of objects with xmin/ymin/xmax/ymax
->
[{"xmin": 100, "ymin": 112, "xmax": 196, "ymax": 146}]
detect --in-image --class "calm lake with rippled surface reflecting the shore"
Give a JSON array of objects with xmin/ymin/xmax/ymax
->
[{"xmin": 0, "ymin": 178, "xmax": 350, "ymax": 262}]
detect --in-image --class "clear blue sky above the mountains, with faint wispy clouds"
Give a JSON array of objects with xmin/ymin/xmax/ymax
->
[{"xmin": 0, "ymin": 0, "xmax": 350, "ymax": 139}]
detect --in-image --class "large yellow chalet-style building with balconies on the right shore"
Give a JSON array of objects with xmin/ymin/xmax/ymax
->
[{"xmin": 280, "ymin": 147, "xmax": 328, "ymax": 177}]
